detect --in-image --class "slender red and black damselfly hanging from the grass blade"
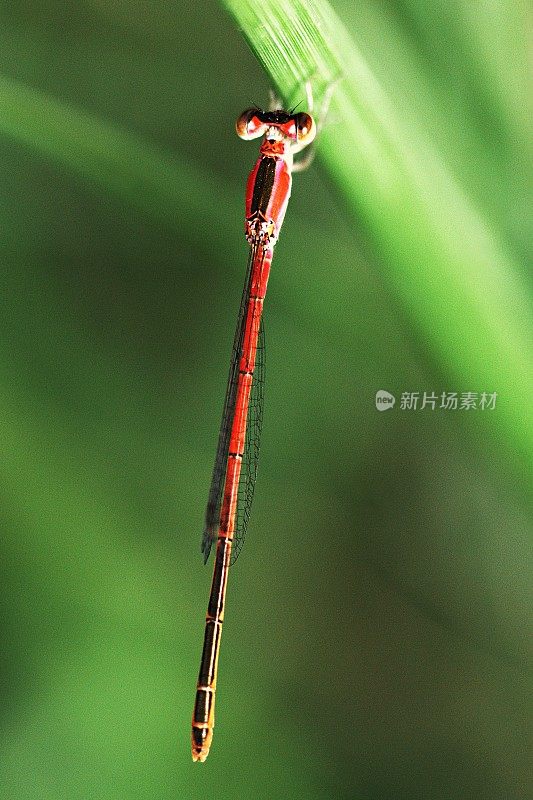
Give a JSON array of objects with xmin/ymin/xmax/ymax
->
[{"xmin": 192, "ymin": 100, "xmax": 317, "ymax": 762}]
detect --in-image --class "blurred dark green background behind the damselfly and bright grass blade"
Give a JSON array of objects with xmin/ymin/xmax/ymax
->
[{"xmin": 0, "ymin": 0, "xmax": 533, "ymax": 800}]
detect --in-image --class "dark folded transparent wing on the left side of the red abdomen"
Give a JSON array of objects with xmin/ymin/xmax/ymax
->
[{"xmin": 202, "ymin": 247, "xmax": 255, "ymax": 564}]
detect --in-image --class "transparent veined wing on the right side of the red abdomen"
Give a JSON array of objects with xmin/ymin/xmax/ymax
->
[{"xmin": 230, "ymin": 319, "xmax": 265, "ymax": 564}]
